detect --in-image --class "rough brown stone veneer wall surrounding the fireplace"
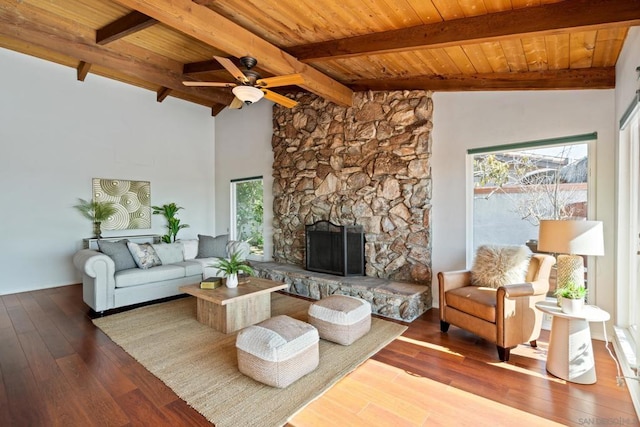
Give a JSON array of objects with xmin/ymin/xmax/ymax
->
[{"xmin": 272, "ymin": 91, "xmax": 433, "ymax": 285}]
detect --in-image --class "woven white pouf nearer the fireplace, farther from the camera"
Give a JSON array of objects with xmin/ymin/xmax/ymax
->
[{"xmin": 309, "ymin": 295, "xmax": 371, "ymax": 345}]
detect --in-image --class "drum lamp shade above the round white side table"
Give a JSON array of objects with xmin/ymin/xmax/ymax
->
[{"xmin": 538, "ymin": 220, "xmax": 604, "ymax": 256}]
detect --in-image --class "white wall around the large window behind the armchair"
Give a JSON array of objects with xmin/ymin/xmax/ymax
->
[{"xmin": 431, "ymin": 90, "xmax": 616, "ymax": 313}]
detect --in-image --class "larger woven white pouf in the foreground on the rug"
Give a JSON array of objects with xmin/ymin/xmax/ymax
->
[{"xmin": 236, "ymin": 316, "xmax": 319, "ymax": 388}]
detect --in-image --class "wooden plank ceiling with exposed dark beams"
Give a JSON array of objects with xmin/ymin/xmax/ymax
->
[{"xmin": 0, "ymin": 0, "xmax": 640, "ymax": 115}]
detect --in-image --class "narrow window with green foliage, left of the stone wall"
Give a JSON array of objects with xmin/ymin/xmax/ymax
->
[{"xmin": 230, "ymin": 176, "xmax": 264, "ymax": 260}]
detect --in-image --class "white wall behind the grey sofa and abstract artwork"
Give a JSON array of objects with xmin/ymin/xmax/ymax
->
[{"xmin": 0, "ymin": 49, "xmax": 215, "ymax": 294}]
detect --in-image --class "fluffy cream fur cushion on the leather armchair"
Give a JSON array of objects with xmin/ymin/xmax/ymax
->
[{"xmin": 471, "ymin": 245, "xmax": 531, "ymax": 288}]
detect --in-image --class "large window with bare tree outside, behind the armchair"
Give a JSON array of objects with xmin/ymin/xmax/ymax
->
[{"xmin": 469, "ymin": 134, "xmax": 596, "ymax": 292}]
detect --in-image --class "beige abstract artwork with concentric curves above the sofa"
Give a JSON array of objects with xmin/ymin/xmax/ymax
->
[{"xmin": 93, "ymin": 178, "xmax": 151, "ymax": 230}]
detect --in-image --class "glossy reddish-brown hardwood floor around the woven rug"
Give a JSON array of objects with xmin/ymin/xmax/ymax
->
[{"xmin": 0, "ymin": 285, "xmax": 640, "ymax": 427}]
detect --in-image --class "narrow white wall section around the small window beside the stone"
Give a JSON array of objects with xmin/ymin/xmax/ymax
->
[{"xmin": 215, "ymin": 99, "xmax": 273, "ymax": 261}]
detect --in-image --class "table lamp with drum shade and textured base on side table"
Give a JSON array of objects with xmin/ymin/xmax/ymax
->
[{"xmin": 538, "ymin": 220, "xmax": 604, "ymax": 288}]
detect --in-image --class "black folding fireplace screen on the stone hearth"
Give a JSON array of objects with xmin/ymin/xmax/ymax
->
[{"xmin": 305, "ymin": 221, "xmax": 364, "ymax": 276}]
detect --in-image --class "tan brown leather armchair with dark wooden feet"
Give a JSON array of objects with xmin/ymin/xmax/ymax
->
[{"xmin": 438, "ymin": 254, "xmax": 555, "ymax": 361}]
